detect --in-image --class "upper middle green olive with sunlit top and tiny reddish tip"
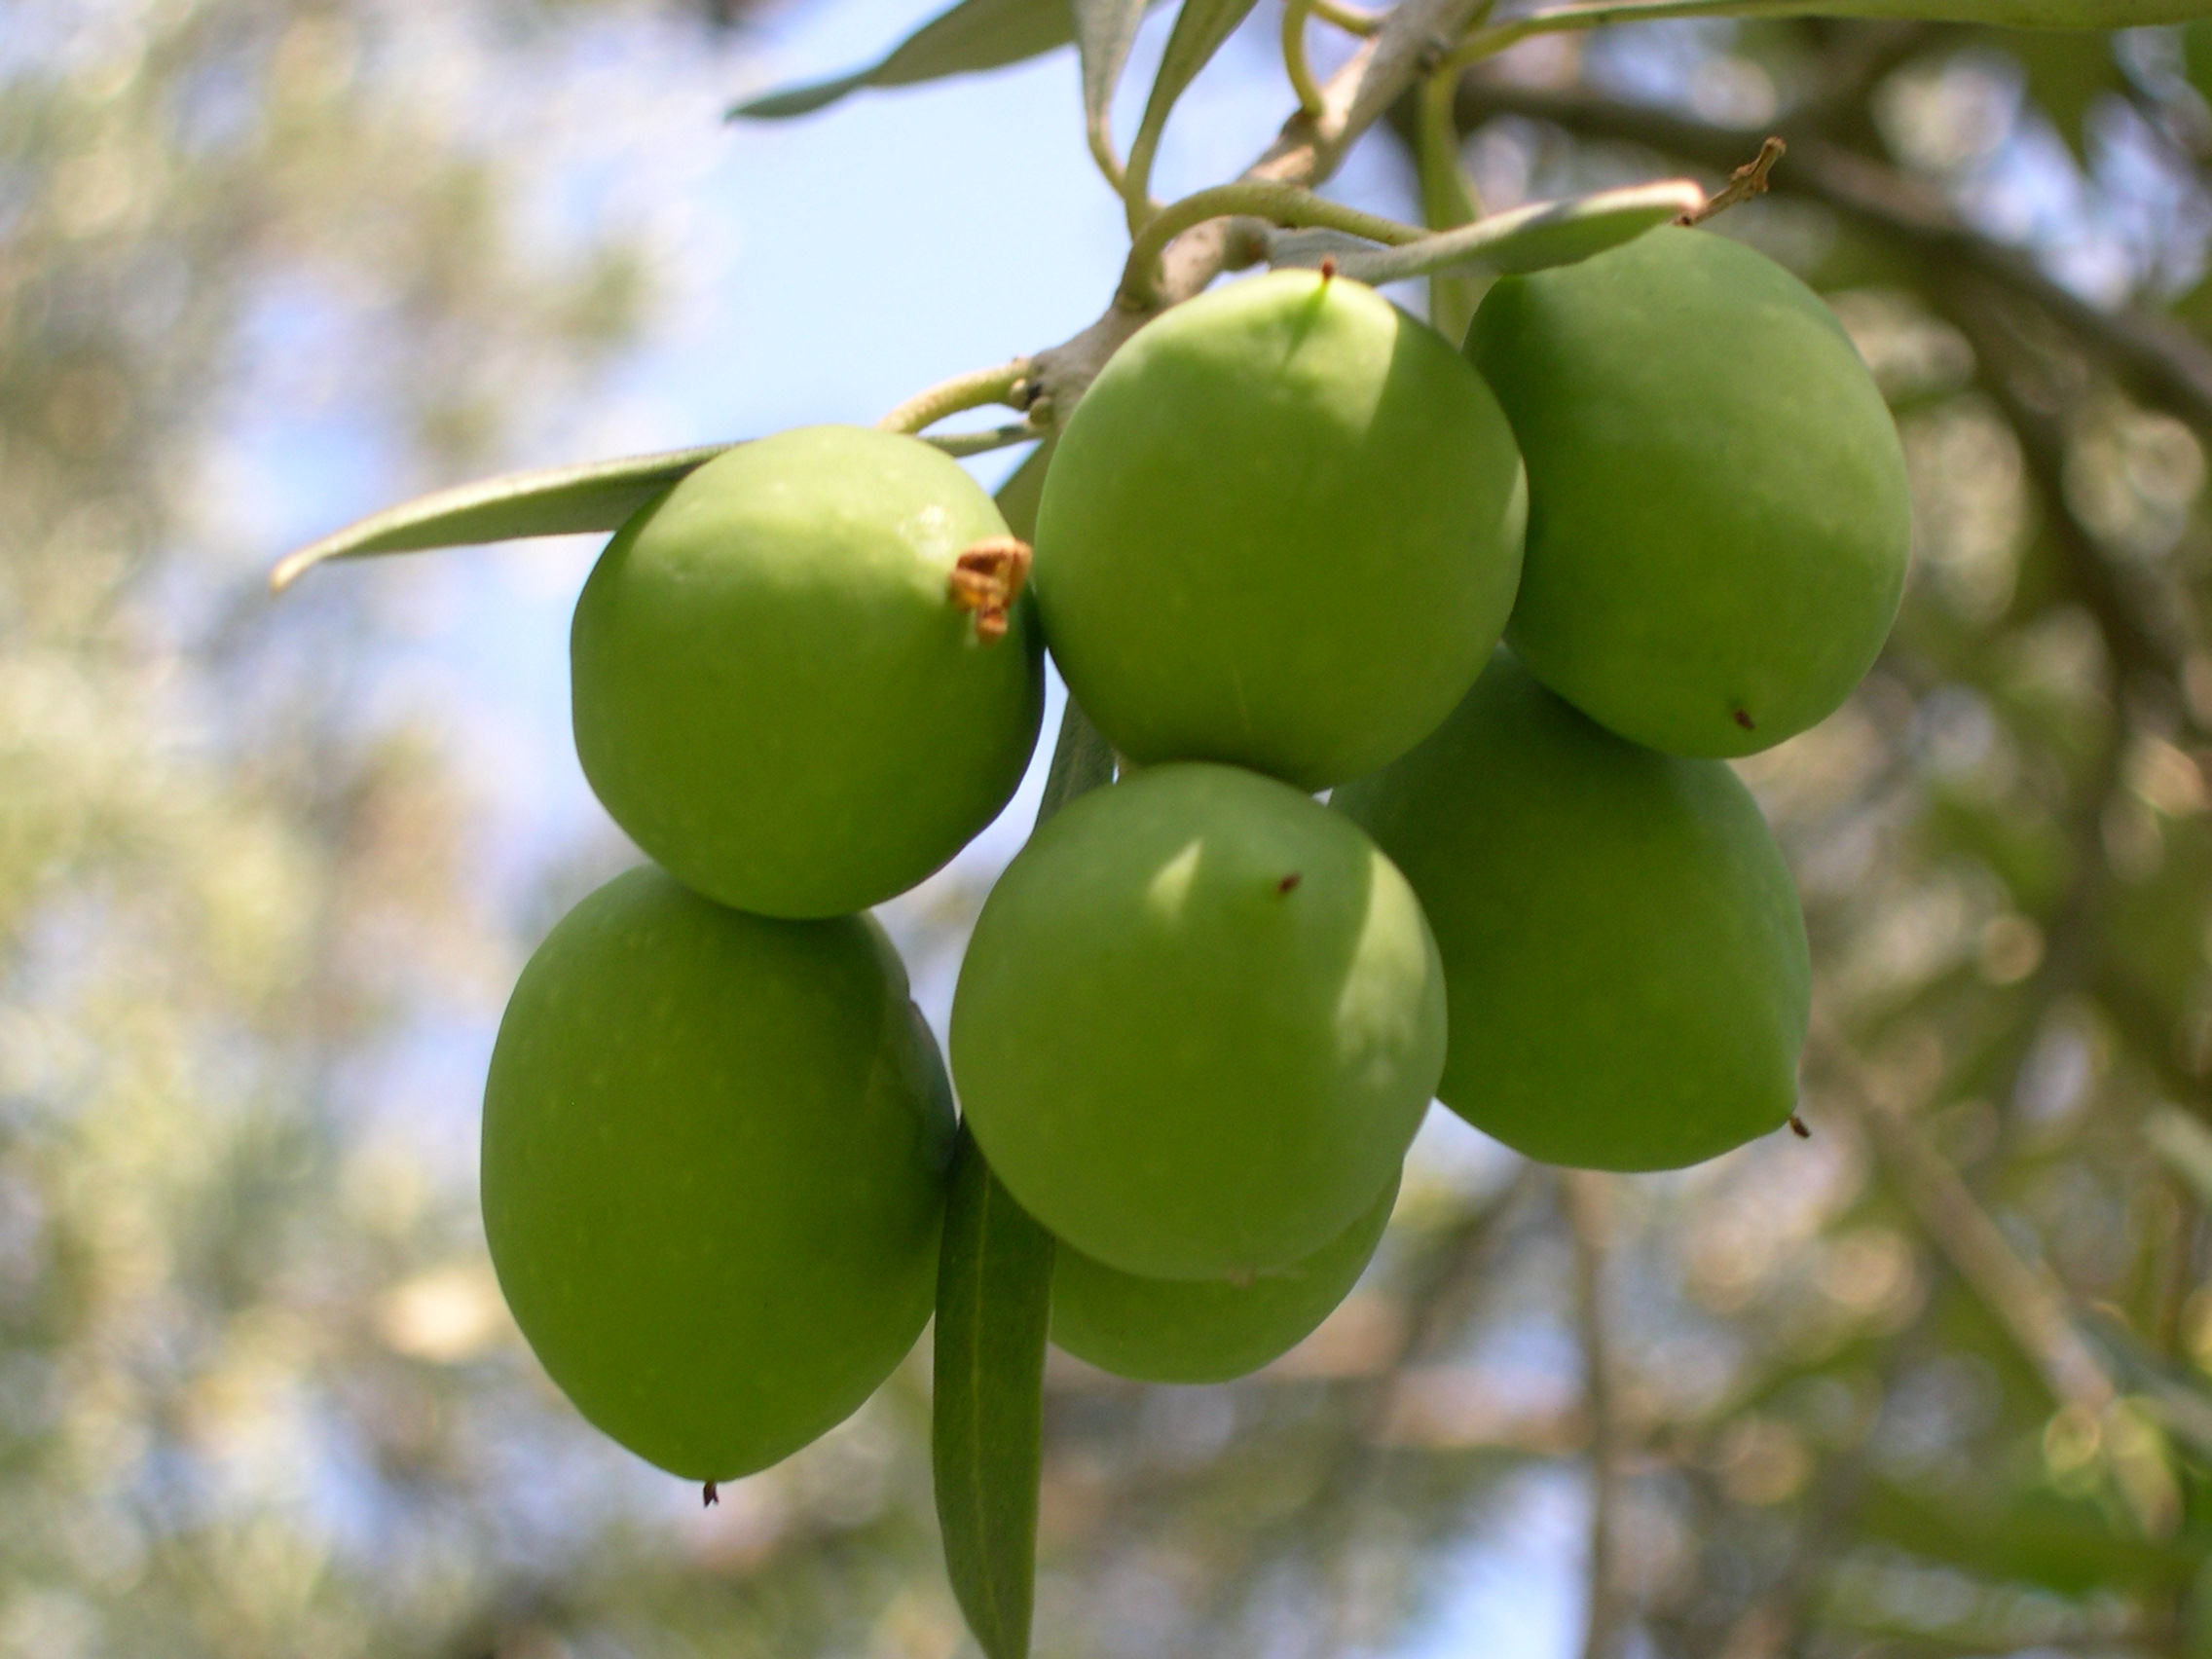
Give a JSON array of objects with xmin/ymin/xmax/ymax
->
[{"xmin": 1038, "ymin": 270, "xmax": 1527, "ymax": 790}]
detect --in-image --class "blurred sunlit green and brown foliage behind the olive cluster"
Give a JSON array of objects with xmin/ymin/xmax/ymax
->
[{"xmin": 0, "ymin": 0, "xmax": 2212, "ymax": 1659}]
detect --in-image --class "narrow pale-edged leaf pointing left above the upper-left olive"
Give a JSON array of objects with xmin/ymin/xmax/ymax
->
[{"xmin": 270, "ymin": 445, "xmax": 730, "ymax": 593}]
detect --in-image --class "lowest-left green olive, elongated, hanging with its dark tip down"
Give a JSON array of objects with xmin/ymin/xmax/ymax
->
[{"xmin": 482, "ymin": 867, "xmax": 953, "ymax": 1480}]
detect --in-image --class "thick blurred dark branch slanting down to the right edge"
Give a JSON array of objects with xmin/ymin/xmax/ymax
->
[{"xmin": 1456, "ymin": 75, "xmax": 2212, "ymax": 442}]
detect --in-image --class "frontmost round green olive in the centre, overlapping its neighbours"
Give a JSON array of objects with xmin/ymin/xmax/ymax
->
[{"xmin": 951, "ymin": 761, "xmax": 1445, "ymax": 1278}]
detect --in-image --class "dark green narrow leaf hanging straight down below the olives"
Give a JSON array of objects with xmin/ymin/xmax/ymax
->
[{"xmin": 932, "ymin": 1128, "xmax": 1052, "ymax": 1659}]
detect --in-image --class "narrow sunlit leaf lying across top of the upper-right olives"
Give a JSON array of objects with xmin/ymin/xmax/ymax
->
[{"xmin": 1268, "ymin": 179, "xmax": 1706, "ymax": 283}]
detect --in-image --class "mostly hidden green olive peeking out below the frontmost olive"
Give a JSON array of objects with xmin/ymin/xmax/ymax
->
[{"xmin": 1052, "ymin": 1174, "xmax": 1398, "ymax": 1382}]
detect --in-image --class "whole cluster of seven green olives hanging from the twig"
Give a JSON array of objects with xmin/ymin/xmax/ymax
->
[{"xmin": 482, "ymin": 230, "xmax": 1909, "ymax": 1480}]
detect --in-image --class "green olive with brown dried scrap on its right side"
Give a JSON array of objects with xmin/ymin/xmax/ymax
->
[{"xmin": 569, "ymin": 426, "xmax": 1044, "ymax": 916}]
